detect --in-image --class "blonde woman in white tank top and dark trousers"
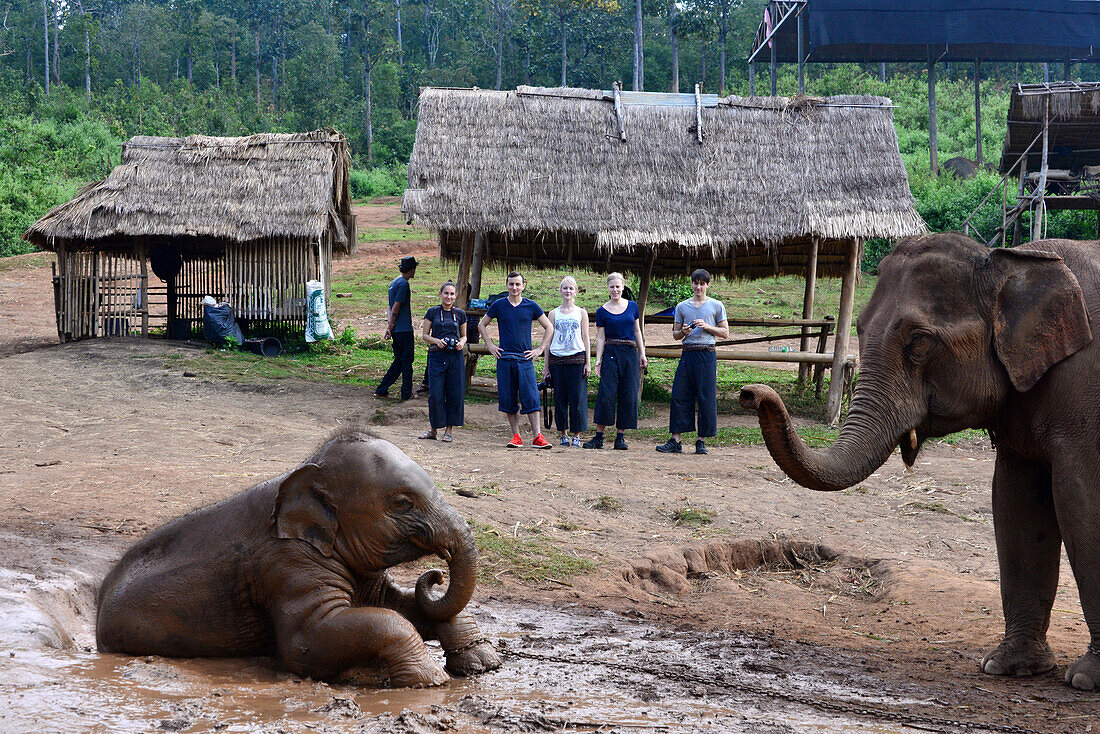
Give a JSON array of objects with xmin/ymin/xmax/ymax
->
[{"xmin": 542, "ymin": 275, "xmax": 592, "ymax": 448}]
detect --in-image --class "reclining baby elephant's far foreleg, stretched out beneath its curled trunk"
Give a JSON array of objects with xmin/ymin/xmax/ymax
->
[{"xmin": 378, "ymin": 574, "xmax": 501, "ymax": 676}]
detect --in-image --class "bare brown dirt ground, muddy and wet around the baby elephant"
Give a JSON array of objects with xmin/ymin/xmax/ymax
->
[{"xmin": 0, "ymin": 207, "xmax": 1100, "ymax": 732}]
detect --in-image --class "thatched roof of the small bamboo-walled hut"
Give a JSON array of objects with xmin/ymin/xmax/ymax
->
[{"xmin": 23, "ymin": 130, "xmax": 355, "ymax": 251}]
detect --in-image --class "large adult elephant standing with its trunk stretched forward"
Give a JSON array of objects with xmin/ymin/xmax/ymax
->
[{"xmin": 740, "ymin": 234, "xmax": 1100, "ymax": 690}]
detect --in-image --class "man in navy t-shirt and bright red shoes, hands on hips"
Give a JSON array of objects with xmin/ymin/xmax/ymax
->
[{"xmin": 477, "ymin": 272, "xmax": 553, "ymax": 449}]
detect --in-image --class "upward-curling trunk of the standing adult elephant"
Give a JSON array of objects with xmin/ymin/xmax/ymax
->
[{"xmin": 740, "ymin": 385, "xmax": 915, "ymax": 492}]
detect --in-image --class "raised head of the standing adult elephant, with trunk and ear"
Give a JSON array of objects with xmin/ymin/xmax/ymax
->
[{"xmin": 740, "ymin": 233, "xmax": 1092, "ymax": 491}]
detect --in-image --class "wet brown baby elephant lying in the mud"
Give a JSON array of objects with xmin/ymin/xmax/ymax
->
[{"xmin": 96, "ymin": 429, "xmax": 501, "ymax": 686}]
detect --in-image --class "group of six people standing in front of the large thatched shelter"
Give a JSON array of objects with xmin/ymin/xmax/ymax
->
[{"xmin": 375, "ymin": 256, "xmax": 729, "ymax": 453}]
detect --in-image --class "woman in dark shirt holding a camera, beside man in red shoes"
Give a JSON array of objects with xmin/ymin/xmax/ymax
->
[{"xmin": 418, "ymin": 281, "xmax": 466, "ymax": 442}]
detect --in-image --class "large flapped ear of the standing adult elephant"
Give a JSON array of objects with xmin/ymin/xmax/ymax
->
[{"xmin": 990, "ymin": 249, "xmax": 1092, "ymax": 392}]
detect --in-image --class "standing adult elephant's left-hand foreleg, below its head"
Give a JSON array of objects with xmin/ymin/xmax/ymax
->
[{"xmin": 981, "ymin": 449, "xmax": 1062, "ymax": 676}]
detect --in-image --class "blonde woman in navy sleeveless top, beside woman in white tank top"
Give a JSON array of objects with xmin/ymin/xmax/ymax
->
[{"xmin": 583, "ymin": 273, "xmax": 649, "ymax": 451}]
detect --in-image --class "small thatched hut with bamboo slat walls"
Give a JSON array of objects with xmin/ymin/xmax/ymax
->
[{"xmin": 23, "ymin": 130, "xmax": 355, "ymax": 341}]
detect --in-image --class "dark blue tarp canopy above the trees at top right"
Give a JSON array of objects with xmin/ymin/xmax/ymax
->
[{"xmin": 750, "ymin": 0, "xmax": 1100, "ymax": 62}]
